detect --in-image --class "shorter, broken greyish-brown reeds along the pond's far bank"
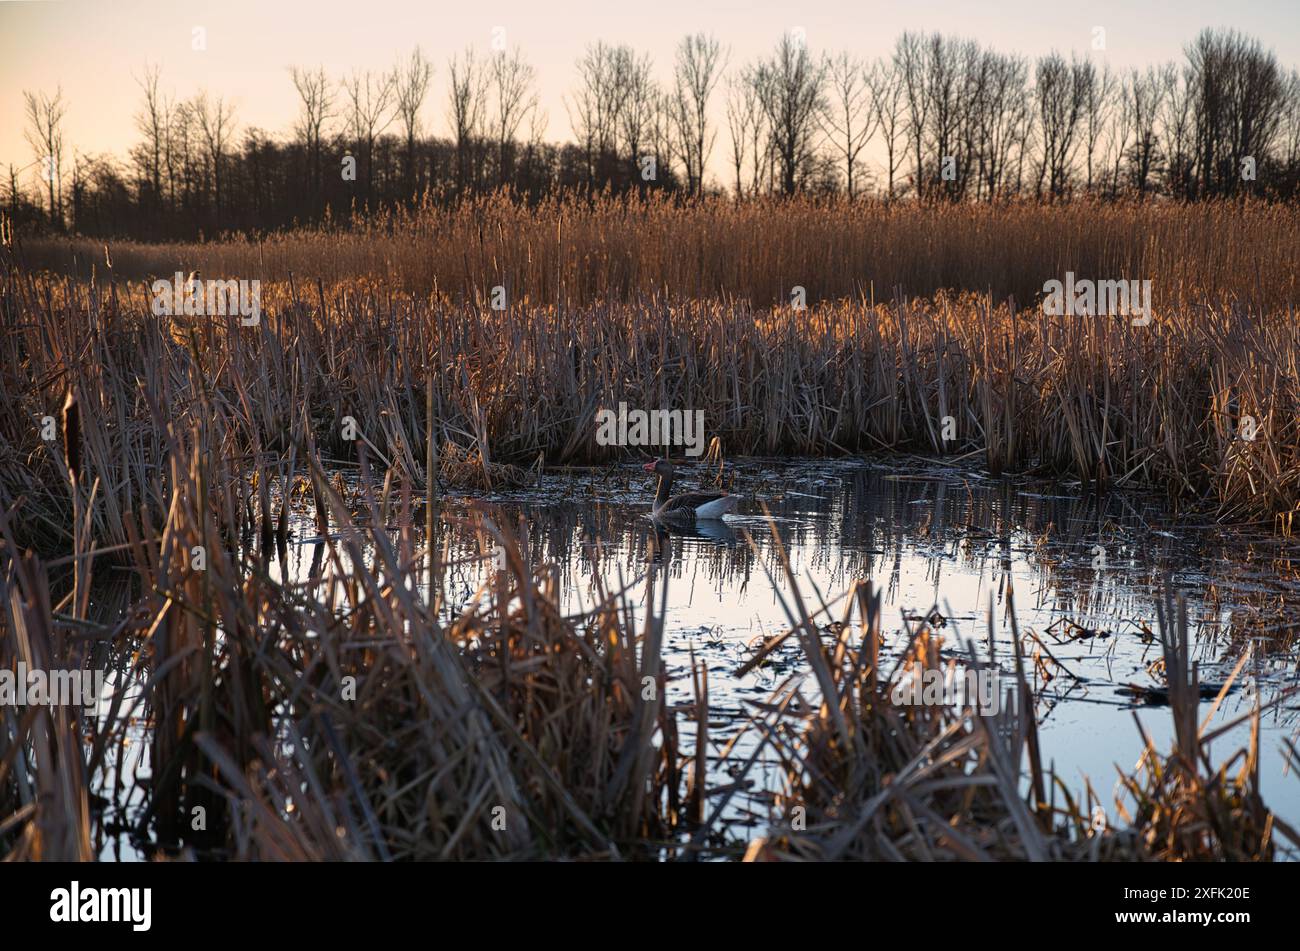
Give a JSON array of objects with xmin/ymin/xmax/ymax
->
[{"xmin": 0, "ymin": 255, "xmax": 1300, "ymax": 551}]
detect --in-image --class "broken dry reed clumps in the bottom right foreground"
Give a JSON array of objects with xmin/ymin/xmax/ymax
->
[{"xmin": 746, "ymin": 543, "xmax": 1300, "ymax": 861}]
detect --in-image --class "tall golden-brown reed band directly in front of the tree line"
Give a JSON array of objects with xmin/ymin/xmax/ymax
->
[{"xmin": 23, "ymin": 194, "xmax": 1300, "ymax": 309}]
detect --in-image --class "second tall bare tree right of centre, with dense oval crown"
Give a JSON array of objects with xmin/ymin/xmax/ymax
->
[{"xmin": 751, "ymin": 34, "xmax": 826, "ymax": 195}]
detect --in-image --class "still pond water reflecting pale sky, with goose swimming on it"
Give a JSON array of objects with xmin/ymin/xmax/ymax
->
[{"xmin": 263, "ymin": 457, "xmax": 1300, "ymax": 831}]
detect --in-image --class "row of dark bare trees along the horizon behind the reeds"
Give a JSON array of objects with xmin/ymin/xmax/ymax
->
[{"xmin": 5, "ymin": 30, "xmax": 1300, "ymax": 239}]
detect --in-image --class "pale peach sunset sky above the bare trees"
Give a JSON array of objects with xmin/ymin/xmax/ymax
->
[{"xmin": 0, "ymin": 0, "xmax": 1300, "ymax": 184}]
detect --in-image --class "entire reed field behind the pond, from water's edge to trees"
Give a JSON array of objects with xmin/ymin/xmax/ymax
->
[{"xmin": 4, "ymin": 196, "xmax": 1300, "ymax": 526}]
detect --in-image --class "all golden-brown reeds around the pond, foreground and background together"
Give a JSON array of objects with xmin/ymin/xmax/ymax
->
[{"xmin": 0, "ymin": 197, "xmax": 1300, "ymax": 860}]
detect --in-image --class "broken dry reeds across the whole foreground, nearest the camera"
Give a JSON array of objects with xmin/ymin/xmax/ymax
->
[{"xmin": 0, "ymin": 439, "xmax": 1300, "ymax": 861}]
